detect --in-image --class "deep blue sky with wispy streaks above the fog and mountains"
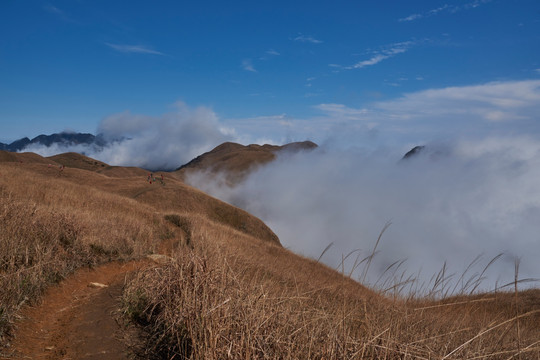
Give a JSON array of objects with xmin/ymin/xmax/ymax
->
[{"xmin": 0, "ymin": 0, "xmax": 540, "ymax": 146}]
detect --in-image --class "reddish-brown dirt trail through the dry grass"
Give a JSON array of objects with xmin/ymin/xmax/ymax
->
[{"xmin": 0, "ymin": 261, "xmax": 149, "ymax": 360}]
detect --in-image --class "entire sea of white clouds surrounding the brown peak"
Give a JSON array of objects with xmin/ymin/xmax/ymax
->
[{"xmin": 20, "ymin": 80, "xmax": 540, "ymax": 295}]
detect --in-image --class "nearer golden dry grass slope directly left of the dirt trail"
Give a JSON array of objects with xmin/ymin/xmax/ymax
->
[{"xmin": 0, "ymin": 163, "xmax": 166, "ymax": 342}]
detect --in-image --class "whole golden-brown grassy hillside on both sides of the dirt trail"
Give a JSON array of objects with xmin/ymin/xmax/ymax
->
[{"xmin": 0, "ymin": 153, "xmax": 540, "ymax": 359}]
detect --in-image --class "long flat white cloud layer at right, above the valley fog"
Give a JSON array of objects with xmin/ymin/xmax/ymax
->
[{"xmin": 224, "ymin": 80, "xmax": 540, "ymax": 148}]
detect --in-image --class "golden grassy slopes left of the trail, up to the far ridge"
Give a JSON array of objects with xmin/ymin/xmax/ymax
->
[{"xmin": 0, "ymin": 152, "xmax": 278, "ymax": 339}]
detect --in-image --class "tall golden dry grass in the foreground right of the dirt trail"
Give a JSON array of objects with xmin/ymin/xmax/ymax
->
[{"xmin": 125, "ymin": 218, "xmax": 540, "ymax": 359}]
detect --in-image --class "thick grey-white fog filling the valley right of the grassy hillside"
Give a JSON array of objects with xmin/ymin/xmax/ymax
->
[{"xmin": 188, "ymin": 137, "xmax": 540, "ymax": 295}]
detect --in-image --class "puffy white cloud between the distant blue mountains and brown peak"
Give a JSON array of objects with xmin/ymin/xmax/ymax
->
[{"xmin": 24, "ymin": 102, "xmax": 235, "ymax": 170}]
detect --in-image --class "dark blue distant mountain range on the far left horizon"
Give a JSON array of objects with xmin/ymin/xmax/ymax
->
[{"xmin": 0, "ymin": 132, "xmax": 106, "ymax": 152}]
